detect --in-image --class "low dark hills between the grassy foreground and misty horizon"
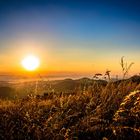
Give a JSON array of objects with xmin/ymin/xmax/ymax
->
[{"xmin": 0, "ymin": 75, "xmax": 140, "ymax": 98}]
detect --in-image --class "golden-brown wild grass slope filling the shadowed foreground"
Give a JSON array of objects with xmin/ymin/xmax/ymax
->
[{"xmin": 0, "ymin": 76, "xmax": 140, "ymax": 140}]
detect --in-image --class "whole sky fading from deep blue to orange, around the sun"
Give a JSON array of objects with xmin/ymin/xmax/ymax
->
[{"xmin": 0, "ymin": 0, "xmax": 140, "ymax": 75}]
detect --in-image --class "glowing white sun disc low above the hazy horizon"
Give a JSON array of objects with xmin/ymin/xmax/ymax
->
[{"xmin": 21, "ymin": 55, "xmax": 40, "ymax": 71}]
